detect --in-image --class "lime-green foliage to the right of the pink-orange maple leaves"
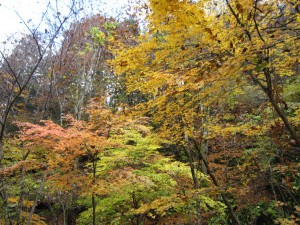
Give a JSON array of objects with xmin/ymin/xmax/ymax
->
[{"xmin": 77, "ymin": 125, "xmax": 225, "ymax": 224}]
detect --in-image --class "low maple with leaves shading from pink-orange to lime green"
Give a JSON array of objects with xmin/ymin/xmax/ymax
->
[{"xmin": 0, "ymin": 99, "xmax": 225, "ymax": 224}]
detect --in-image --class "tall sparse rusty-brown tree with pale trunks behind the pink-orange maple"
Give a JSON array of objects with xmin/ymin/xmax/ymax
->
[{"xmin": 27, "ymin": 14, "xmax": 141, "ymax": 124}]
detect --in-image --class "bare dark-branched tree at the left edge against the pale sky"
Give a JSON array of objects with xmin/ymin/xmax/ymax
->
[{"xmin": 0, "ymin": 2, "xmax": 78, "ymax": 165}]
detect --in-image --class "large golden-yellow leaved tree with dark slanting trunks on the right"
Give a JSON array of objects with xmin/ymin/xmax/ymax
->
[{"xmin": 113, "ymin": 1, "xmax": 299, "ymax": 224}]
